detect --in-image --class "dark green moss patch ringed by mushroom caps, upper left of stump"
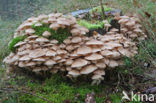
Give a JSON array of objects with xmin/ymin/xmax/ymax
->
[{"xmin": 32, "ymin": 24, "xmax": 72, "ymax": 43}]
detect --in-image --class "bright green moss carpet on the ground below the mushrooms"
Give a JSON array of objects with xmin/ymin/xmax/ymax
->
[{"xmin": 15, "ymin": 74, "xmax": 107, "ymax": 103}]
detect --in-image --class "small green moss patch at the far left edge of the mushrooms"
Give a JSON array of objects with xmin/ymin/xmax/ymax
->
[{"xmin": 8, "ymin": 36, "xmax": 27, "ymax": 52}]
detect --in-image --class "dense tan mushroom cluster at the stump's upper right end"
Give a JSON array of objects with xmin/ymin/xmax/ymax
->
[{"xmin": 113, "ymin": 15, "xmax": 147, "ymax": 40}]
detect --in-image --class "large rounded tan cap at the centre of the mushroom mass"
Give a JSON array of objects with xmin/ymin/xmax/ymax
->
[{"xmin": 77, "ymin": 46, "xmax": 92, "ymax": 55}]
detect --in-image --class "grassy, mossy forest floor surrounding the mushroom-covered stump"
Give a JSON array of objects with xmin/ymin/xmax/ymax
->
[{"xmin": 0, "ymin": 0, "xmax": 156, "ymax": 103}]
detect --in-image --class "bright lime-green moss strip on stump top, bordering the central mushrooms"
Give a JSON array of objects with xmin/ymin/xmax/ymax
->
[{"xmin": 78, "ymin": 20, "xmax": 104, "ymax": 30}]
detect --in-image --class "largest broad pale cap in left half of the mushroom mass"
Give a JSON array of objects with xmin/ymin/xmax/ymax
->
[{"xmin": 29, "ymin": 49, "xmax": 46, "ymax": 58}]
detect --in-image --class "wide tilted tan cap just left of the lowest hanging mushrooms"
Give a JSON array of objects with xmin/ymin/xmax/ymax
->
[{"xmin": 80, "ymin": 64, "xmax": 97, "ymax": 74}]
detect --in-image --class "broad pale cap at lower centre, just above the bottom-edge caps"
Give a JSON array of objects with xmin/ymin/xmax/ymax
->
[{"xmin": 71, "ymin": 59, "xmax": 88, "ymax": 68}]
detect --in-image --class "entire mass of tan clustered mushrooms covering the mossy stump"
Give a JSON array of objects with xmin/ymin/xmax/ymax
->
[{"xmin": 4, "ymin": 13, "xmax": 145, "ymax": 83}]
